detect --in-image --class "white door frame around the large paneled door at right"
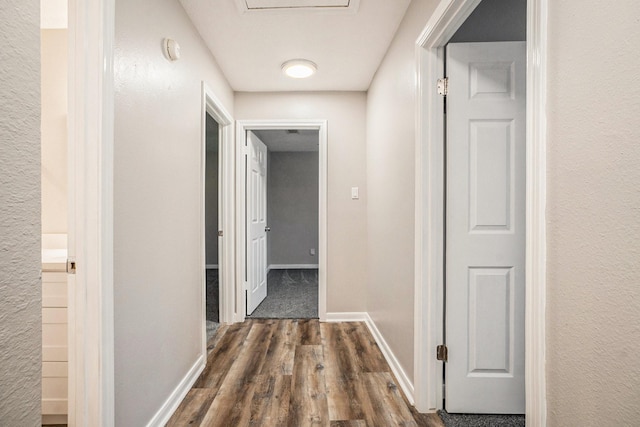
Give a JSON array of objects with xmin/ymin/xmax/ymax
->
[{"xmin": 414, "ymin": 0, "xmax": 548, "ymax": 426}]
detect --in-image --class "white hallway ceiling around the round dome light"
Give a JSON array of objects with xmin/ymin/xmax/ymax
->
[{"xmin": 178, "ymin": 0, "xmax": 410, "ymax": 92}]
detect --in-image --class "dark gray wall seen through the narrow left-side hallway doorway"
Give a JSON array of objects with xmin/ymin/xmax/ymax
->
[{"xmin": 204, "ymin": 114, "xmax": 219, "ymax": 264}]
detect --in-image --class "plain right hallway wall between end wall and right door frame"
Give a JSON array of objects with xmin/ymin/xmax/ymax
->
[{"xmin": 367, "ymin": 0, "xmax": 437, "ymax": 384}]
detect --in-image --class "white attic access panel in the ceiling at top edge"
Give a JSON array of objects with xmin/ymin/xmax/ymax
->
[{"xmin": 236, "ymin": 0, "xmax": 360, "ymax": 13}]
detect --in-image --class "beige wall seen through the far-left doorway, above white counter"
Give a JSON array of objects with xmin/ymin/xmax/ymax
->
[{"xmin": 40, "ymin": 29, "xmax": 68, "ymax": 233}]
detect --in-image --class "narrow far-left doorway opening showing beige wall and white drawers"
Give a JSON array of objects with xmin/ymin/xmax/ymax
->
[{"xmin": 40, "ymin": 2, "xmax": 75, "ymax": 425}]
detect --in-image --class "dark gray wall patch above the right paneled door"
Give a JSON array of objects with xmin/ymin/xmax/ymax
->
[{"xmin": 449, "ymin": 0, "xmax": 527, "ymax": 43}]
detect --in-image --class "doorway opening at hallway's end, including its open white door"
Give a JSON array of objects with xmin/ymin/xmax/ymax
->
[{"xmin": 247, "ymin": 129, "xmax": 319, "ymax": 319}]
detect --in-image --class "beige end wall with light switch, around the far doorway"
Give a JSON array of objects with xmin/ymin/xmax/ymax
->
[{"xmin": 235, "ymin": 92, "xmax": 367, "ymax": 312}]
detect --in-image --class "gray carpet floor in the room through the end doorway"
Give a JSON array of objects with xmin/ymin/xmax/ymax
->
[{"xmin": 248, "ymin": 269, "xmax": 318, "ymax": 319}]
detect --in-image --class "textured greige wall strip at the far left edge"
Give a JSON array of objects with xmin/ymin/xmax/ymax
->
[{"xmin": 0, "ymin": 0, "xmax": 42, "ymax": 427}]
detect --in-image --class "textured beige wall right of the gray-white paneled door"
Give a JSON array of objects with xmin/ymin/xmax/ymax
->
[{"xmin": 547, "ymin": 0, "xmax": 640, "ymax": 426}]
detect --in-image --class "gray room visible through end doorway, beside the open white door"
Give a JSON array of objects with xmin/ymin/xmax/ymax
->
[{"xmin": 247, "ymin": 129, "xmax": 319, "ymax": 319}]
